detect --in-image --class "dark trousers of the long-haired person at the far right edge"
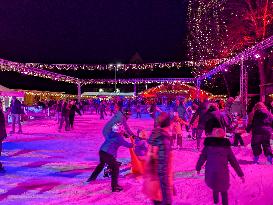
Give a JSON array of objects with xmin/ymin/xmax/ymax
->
[{"xmin": 251, "ymin": 134, "xmax": 272, "ymax": 157}]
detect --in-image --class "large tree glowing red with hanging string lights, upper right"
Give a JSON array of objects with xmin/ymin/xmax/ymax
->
[{"xmin": 188, "ymin": 0, "xmax": 273, "ymax": 99}]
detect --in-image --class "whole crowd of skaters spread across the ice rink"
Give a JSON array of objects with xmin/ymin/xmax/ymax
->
[{"xmin": 0, "ymin": 97, "xmax": 273, "ymax": 205}]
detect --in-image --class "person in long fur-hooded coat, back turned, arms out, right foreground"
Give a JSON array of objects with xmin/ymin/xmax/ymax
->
[{"xmin": 196, "ymin": 118, "xmax": 244, "ymax": 205}]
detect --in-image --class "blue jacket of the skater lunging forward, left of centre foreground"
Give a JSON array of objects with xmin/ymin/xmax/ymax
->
[{"xmin": 100, "ymin": 132, "xmax": 133, "ymax": 157}]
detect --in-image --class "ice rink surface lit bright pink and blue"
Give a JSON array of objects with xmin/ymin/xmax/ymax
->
[{"xmin": 0, "ymin": 115, "xmax": 273, "ymax": 205}]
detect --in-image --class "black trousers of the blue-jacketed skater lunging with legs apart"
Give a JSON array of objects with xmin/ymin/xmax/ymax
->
[{"xmin": 90, "ymin": 150, "xmax": 119, "ymax": 188}]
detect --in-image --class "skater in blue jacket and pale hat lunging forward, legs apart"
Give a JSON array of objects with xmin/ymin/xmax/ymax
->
[{"xmin": 87, "ymin": 123, "xmax": 133, "ymax": 192}]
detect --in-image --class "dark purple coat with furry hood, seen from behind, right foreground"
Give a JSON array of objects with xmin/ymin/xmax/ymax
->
[{"xmin": 196, "ymin": 137, "xmax": 244, "ymax": 192}]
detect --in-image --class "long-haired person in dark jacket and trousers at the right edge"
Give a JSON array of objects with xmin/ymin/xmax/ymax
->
[{"xmin": 246, "ymin": 102, "xmax": 273, "ymax": 164}]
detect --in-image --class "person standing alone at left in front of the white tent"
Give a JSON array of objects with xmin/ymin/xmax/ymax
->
[{"xmin": 10, "ymin": 96, "xmax": 22, "ymax": 134}]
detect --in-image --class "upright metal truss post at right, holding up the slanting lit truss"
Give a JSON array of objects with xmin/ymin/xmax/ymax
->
[{"xmin": 240, "ymin": 58, "xmax": 248, "ymax": 117}]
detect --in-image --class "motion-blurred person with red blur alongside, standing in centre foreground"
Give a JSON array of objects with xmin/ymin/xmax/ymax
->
[{"xmin": 143, "ymin": 112, "xmax": 174, "ymax": 205}]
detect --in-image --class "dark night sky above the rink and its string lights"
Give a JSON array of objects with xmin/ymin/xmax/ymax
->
[{"xmin": 0, "ymin": 0, "xmax": 188, "ymax": 93}]
